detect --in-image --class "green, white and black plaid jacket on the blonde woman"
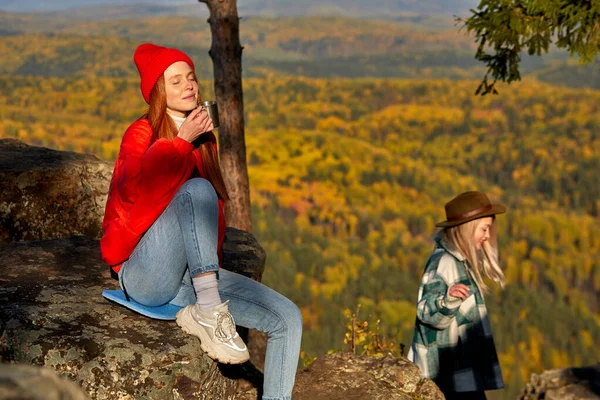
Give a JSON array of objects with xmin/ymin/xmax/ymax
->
[{"xmin": 408, "ymin": 237, "xmax": 504, "ymax": 392}]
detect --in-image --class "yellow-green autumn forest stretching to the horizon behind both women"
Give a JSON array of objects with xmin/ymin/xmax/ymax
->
[{"xmin": 0, "ymin": 7, "xmax": 600, "ymax": 399}]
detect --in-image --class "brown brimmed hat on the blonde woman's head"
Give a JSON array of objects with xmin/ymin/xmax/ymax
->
[{"xmin": 435, "ymin": 192, "xmax": 506, "ymax": 228}]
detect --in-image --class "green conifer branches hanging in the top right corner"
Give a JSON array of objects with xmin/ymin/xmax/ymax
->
[{"xmin": 459, "ymin": 0, "xmax": 600, "ymax": 95}]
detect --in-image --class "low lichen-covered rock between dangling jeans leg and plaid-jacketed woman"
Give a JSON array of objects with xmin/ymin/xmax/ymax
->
[{"xmin": 293, "ymin": 353, "xmax": 444, "ymax": 400}]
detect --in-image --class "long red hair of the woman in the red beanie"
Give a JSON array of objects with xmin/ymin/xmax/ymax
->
[{"xmin": 143, "ymin": 75, "xmax": 229, "ymax": 200}]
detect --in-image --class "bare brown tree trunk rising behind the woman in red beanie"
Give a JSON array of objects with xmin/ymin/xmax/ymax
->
[{"xmin": 198, "ymin": 0, "xmax": 252, "ymax": 232}]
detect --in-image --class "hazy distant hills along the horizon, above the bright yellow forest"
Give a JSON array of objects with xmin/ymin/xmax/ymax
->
[{"xmin": 0, "ymin": 13, "xmax": 600, "ymax": 89}]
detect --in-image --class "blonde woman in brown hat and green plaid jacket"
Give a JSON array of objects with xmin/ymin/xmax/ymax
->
[{"xmin": 408, "ymin": 192, "xmax": 506, "ymax": 400}]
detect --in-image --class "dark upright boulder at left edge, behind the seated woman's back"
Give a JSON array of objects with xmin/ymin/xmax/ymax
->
[{"xmin": 0, "ymin": 139, "xmax": 113, "ymax": 243}]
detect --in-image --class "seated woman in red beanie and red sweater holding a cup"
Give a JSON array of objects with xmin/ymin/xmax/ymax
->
[{"xmin": 100, "ymin": 44, "xmax": 302, "ymax": 399}]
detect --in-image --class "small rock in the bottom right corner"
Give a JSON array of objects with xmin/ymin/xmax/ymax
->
[{"xmin": 519, "ymin": 363, "xmax": 600, "ymax": 400}]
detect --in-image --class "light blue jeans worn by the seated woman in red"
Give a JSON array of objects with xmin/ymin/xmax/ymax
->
[{"xmin": 119, "ymin": 178, "xmax": 302, "ymax": 400}]
